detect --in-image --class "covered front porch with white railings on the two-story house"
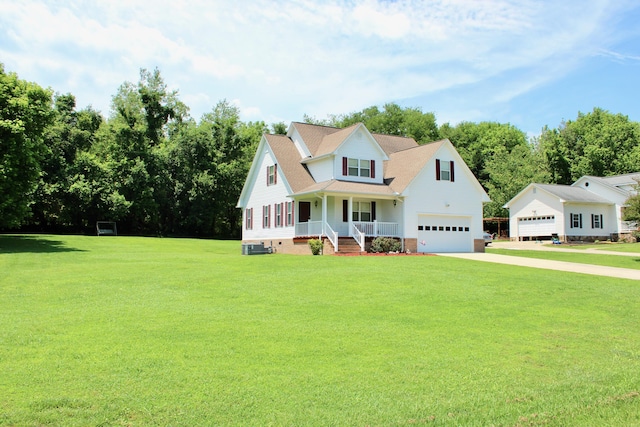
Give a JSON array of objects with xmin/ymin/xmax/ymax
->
[{"xmin": 295, "ymin": 194, "xmax": 403, "ymax": 252}]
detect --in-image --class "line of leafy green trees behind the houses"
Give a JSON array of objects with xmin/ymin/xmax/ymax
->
[{"xmin": 0, "ymin": 64, "xmax": 640, "ymax": 238}]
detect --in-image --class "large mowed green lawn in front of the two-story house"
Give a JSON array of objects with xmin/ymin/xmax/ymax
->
[{"xmin": 0, "ymin": 236, "xmax": 640, "ymax": 426}]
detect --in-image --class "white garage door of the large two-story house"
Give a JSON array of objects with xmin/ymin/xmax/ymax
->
[{"xmin": 418, "ymin": 215, "xmax": 473, "ymax": 253}]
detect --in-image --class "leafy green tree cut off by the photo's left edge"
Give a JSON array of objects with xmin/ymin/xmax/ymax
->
[{"xmin": 0, "ymin": 64, "xmax": 53, "ymax": 228}]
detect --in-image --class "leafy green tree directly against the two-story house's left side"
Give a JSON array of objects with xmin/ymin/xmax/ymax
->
[{"xmin": 169, "ymin": 100, "xmax": 267, "ymax": 237}]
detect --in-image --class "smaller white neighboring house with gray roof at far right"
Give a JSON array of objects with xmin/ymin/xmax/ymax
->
[{"xmin": 504, "ymin": 173, "xmax": 640, "ymax": 242}]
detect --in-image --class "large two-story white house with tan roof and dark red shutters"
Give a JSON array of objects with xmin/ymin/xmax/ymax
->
[{"xmin": 238, "ymin": 122, "xmax": 489, "ymax": 253}]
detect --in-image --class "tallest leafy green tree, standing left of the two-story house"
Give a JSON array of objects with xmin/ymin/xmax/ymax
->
[{"xmin": 98, "ymin": 69, "xmax": 188, "ymax": 234}]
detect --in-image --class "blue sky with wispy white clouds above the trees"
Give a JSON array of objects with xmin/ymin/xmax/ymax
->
[{"xmin": 0, "ymin": 0, "xmax": 640, "ymax": 136}]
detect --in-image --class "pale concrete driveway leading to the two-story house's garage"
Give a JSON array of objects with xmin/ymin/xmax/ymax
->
[{"xmin": 438, "ymin": 242, "xmax": 640, "ymax": 280}]
